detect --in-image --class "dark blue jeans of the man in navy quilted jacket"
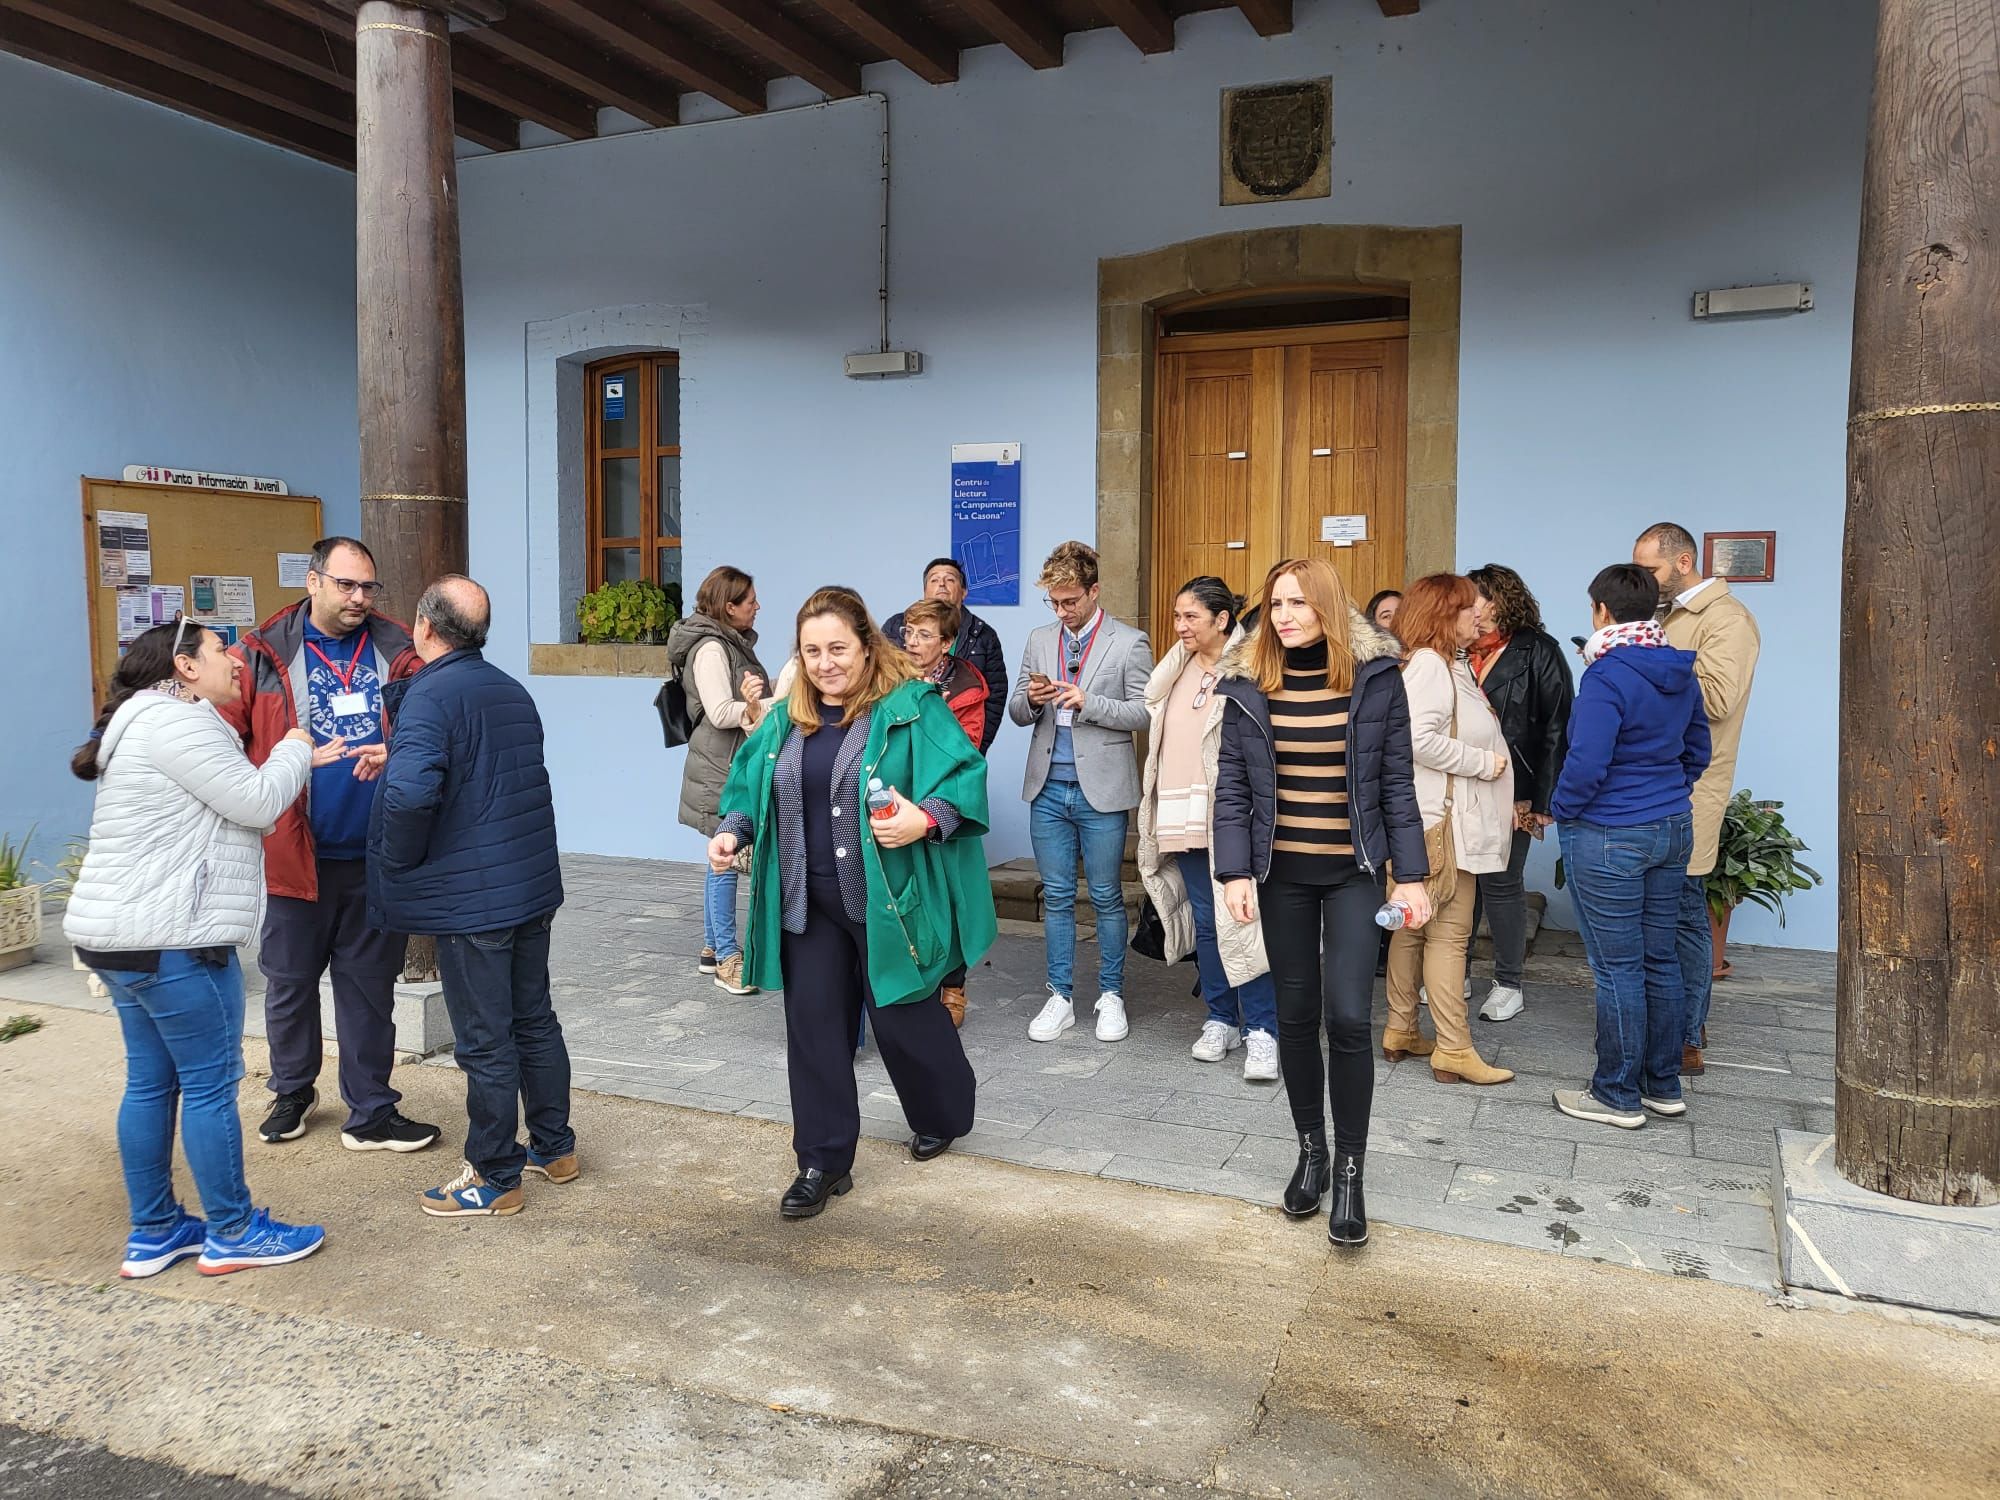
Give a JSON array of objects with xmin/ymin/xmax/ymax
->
[{"xmin": 438, "ymin": 916, "xmax": 576, "ymax": 1188}]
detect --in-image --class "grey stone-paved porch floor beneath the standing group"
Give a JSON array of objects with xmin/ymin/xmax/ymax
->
[{"xmin": 524, "ymin": 856, "xmax": 1834, "ymax": 1286}]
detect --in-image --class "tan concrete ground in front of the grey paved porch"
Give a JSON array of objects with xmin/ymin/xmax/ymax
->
[{"xmin": 0, "ymin": 1010, "xmax": 2000, "ymax": 1500}]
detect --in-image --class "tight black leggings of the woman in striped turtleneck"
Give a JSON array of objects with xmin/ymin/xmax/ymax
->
[{"xmin": 1258, "ymin": 866, "xmax": 1382, "ymax": 1156}]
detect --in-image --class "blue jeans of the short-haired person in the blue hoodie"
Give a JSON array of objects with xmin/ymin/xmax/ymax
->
[{"xmin": 1562, "ymin": 812, "xmax": 1694, "ymax": 1110}]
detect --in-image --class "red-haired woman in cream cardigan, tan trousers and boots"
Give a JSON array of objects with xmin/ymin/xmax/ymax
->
[{"xmin": 1382, "ymin": 572, "xmax": 1514, "ymax": 1084}]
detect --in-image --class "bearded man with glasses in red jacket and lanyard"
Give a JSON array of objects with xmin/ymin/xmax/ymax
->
[{"xmin": 222, "ymin": 536, "xmax": 438, "ymax": 1152}]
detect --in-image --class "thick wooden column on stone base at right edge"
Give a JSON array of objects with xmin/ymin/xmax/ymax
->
[{"xmin": 1834, "ymin": 0, "xmax": 2000, "ymax": 1204}]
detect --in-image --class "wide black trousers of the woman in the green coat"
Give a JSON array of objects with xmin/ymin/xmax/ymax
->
[{"xmin": 784, "ymin": 882, "xmax": 976, "ymax": 1178}]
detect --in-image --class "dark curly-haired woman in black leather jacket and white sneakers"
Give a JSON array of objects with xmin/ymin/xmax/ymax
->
[{"xmin": 1468, "ymin": 562, "xmax": 1576, "ymax": 1020}]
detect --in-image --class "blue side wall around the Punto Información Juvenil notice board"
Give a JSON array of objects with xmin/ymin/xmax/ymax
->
[{"xmin": 0, "ymin": 56, "xmax": 358, "ymax": 876}]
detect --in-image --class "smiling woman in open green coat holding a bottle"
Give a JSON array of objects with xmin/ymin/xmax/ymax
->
[{"xmin": 708, "ymin": 588, "xmax": 998, "ymax": 1218}]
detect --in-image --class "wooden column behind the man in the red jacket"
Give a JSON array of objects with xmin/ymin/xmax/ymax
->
[{"xmin": 354, "ymin": 0, "xmax": 466, "ymax": 620}]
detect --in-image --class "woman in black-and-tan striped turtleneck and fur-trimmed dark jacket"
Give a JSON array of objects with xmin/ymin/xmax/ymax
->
[{"xmin": 1214, "ymin": 558, "xmax": 1430, "ymax": 1246}]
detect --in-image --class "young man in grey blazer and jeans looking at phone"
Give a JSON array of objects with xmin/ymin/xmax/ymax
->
[{"xmin": 1008, "ymin": 542, "xmax": 1152, "ymax": 1042}]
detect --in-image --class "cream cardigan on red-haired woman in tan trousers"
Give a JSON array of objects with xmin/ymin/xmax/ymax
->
[{"xmin": 1402, "ymin": 648, "xmax": 1514, "ymax": 874}]
